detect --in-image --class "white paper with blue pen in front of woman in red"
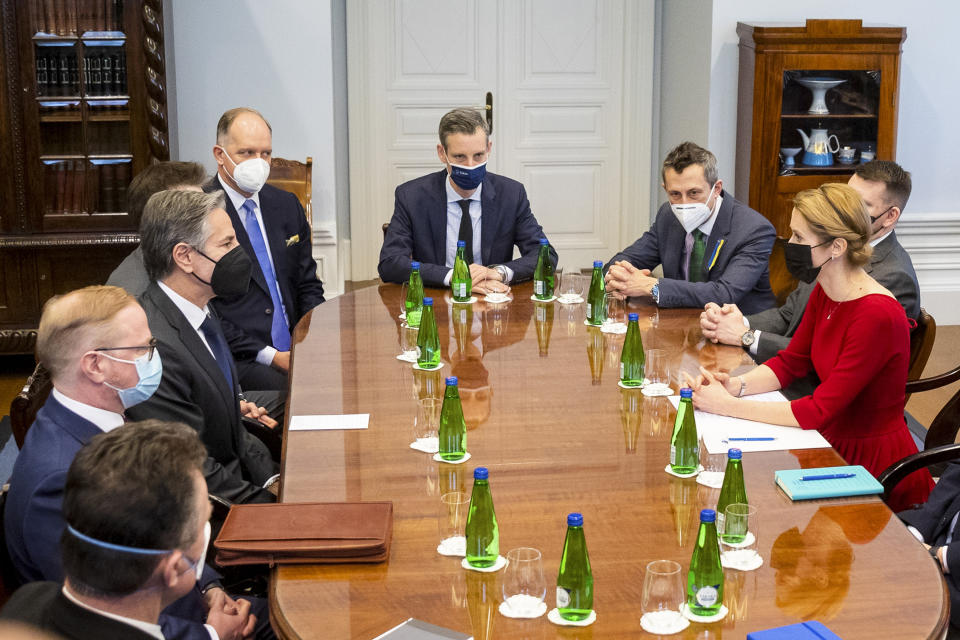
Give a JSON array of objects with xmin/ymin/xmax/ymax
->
[{"xmin": 670, "ymin": 391, "xmax": 830, "ymax": 454}]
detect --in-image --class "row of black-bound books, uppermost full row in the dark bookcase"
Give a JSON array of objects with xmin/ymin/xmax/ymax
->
[{"xmin": 35, "ymin": 47, "xmax": 127, "ymax": 97}]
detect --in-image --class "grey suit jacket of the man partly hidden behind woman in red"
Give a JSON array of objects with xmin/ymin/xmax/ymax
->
[{"xmin": 747, "ymin": 232, "xmax": 920, "ymax": 362}]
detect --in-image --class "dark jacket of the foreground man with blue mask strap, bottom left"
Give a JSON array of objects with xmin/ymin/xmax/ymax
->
[{"xmin": 0, "ymin": 582, "xmax": 156, "ymax": 640}]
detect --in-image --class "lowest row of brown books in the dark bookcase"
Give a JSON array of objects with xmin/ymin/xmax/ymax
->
[{"xmin": 44, "ymin": 160, "xmax": 131, "ymax": 213}]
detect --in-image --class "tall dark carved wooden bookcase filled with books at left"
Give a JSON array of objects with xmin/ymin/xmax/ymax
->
[{"xmin": 0, "ymin": 0, "xmax": 170, "ymax": 353}]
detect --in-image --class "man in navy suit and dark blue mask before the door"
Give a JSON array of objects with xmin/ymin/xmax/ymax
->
[{"xmin": 377, "ymin": 109, "xmax": 557, "ymax": 293}]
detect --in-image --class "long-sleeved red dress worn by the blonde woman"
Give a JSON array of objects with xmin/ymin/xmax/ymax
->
[{"xmin": 766, "ymin": 284, "xmax": 933, "ymax": 511}]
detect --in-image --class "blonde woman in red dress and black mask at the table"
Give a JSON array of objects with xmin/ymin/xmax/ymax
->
[{"xmin": 690, "ymin": 184, "xmax": 933, "ymax": 511}]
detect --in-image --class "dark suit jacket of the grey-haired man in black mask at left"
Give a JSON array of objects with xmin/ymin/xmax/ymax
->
[{"xmin": 127, "ymin": 283, "xmax": 277, "ymax": 502}]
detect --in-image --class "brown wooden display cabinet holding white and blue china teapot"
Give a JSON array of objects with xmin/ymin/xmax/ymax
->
[{"xmin": 736, "ymin": 20, "xmax": 906, "ymax": 298}]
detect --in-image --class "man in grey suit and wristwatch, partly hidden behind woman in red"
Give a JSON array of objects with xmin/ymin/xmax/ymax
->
[{"xmin": 700, "ymin": 160, "xmax": 920, "ymax": 364}]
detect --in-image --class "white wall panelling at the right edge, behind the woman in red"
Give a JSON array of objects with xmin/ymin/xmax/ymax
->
[{"xmin": 897, "ymin": 214, "xmax": 960, "ymax": 325}]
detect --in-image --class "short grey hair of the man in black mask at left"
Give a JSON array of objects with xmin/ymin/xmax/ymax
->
[{"xmin": 140, "ymin": 191, "xmax": 225, "ymax": 281}]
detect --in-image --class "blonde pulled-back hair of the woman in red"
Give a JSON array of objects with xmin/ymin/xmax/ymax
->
[{"xmin": 793, "ymin": 182, "xmax": 873, "ymax": 267}]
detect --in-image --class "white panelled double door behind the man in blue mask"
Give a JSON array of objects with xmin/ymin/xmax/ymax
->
[{"xmin": 347, "ymin": 0, "xmax": 655, "ymax": 280}]
